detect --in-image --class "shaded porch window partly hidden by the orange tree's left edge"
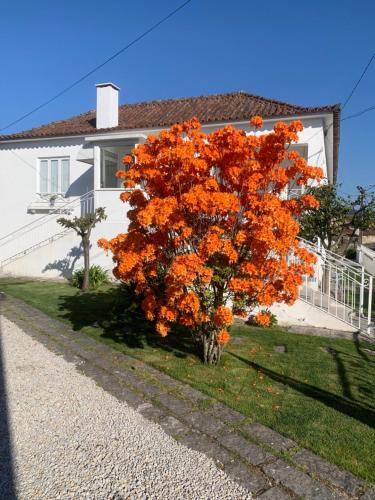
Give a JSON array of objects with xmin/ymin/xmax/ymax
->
[{"xmin": 100, "ymin": 144, "xmax": 134, "ymax": 189}]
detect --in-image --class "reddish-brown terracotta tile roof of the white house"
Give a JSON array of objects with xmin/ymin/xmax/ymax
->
[{"xmin": 0, "ymin": 92, "xmax": 340, "ymax": 179}]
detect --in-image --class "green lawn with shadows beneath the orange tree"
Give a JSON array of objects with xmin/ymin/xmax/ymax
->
[{"xmin": 0, "ymin": 278, "xmax": 375, "ymax": 481}]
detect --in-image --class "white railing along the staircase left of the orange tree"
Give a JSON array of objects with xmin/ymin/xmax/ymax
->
[{"xmin": 0, "ymin": 191, "xmax": 94, "ymax": 268}]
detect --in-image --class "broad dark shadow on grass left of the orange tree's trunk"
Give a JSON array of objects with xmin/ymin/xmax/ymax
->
[{"xmin": 59, "ymin": 286, "xmax": 196, "ymax": 358}]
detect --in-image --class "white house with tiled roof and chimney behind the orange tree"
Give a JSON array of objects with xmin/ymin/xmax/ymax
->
[{"xmin": 7, "ymin": 83, "xmax": 370, "ymax": 336}]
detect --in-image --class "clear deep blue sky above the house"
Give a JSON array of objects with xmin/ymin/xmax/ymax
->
[{"xmin": 0, "ymin": 0, "xmax": 375, "ymax": 193}]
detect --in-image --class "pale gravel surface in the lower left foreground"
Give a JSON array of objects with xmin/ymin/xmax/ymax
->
[{"xmin": 0, "ymin": 318, "xmax": 251, "ymax": 499}]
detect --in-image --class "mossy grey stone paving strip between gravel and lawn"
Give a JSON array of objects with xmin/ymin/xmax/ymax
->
[{"xmin": 0, "ymin": 296, "xmax": 375, "ymax": 500}]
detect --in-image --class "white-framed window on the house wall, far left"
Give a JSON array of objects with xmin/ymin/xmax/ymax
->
[{"xmin": 39, "ymin": 158, "xmax": 70, "ymax": 194}]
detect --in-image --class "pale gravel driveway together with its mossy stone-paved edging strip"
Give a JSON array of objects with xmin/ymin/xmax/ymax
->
[{"xmin": 0, "ymin": 297, "xmax": 375, "ymax": 500}]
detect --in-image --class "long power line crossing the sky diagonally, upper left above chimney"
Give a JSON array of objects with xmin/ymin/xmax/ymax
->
[{"xmin": 0, "ymin": 0, "xmax": 192, "ymax": 132}]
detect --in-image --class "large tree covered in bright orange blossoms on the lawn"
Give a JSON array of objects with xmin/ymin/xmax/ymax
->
[{"xmin": 98, "ymin": 117, "xmax": 322, "ymax": 364}]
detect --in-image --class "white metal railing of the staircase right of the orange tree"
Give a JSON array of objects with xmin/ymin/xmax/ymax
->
[{"xmin": 299, "ymin": 238, "xmax": 375, "ymax": 336}]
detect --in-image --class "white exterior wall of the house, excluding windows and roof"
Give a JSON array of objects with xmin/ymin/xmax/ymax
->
[{"xmin": 0, "ymin": 117, "xmax": 328, "ymax": 278}]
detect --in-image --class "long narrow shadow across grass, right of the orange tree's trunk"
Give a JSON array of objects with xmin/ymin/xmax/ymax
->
[{"xmin": 231, "ymin": 351, "xmax": 375, "ymax": 427}]
